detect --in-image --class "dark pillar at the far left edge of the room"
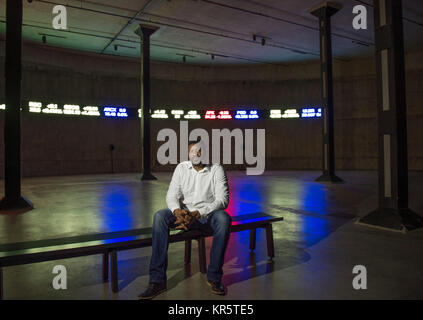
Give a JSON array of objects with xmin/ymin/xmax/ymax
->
[{"xmin": 0, "ymin": 0, "xmax": 32, "ymax": 212}]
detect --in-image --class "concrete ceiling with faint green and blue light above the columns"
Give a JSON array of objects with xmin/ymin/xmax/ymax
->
[{"xmin": 0, "ymin": 0, "xmax": 423, "ymax": 64}]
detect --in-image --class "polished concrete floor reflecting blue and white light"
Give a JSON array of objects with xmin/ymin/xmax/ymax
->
[{"xmin": 0, "ymin": 171, "xmax": 423, "ymax": 300}]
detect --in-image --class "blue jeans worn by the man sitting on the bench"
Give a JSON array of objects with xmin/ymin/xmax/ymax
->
[{"xmin": 150, "ymin": 209, "xmax": 232, "ymax": 283}]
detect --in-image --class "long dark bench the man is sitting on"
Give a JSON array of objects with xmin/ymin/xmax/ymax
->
[{"xmin": 0, "ymin": 212, "xmax": 283, "ymax": 299}]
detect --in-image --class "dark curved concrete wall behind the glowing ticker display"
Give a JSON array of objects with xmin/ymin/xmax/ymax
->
[{"xmin": 0, "ymin": 43, "xmax": 423, "ymax": 176}]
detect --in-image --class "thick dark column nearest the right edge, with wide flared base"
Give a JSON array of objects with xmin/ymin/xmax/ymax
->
[{"xmin": 358, "ymin": 0, "xmax": 423, "ymax": 232}]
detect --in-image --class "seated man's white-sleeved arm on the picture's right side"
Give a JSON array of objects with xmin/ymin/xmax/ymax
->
[{"xmin": 198, "ymin": 166, "xmax": 229, "ymax": 217}]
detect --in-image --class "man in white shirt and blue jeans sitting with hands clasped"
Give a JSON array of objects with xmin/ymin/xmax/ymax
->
[{"xmin": 138, "ymin": 141, "xmax": 232, "ymax": 299}]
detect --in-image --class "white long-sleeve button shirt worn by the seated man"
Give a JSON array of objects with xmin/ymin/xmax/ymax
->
[{"xmin": 166, "ymin": 161, "xmax": 229, "ymax": 218}]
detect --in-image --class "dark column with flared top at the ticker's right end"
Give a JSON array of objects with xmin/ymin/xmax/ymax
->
[{"xmin": 310, "ymin": 1, "xmax": 342, "ymax": 182}]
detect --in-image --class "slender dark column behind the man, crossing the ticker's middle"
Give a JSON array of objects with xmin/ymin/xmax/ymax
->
[{"xmin": 135, "ymin": 24, "xmax": 158, "ymax": 180}]
